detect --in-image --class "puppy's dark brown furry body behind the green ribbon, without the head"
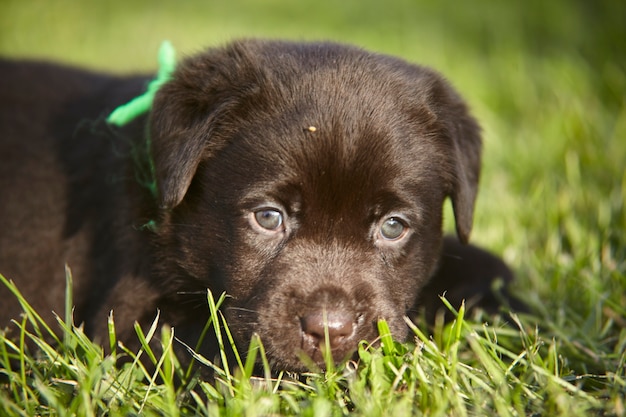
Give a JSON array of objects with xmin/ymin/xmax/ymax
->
[{"xmin": 0, "ymin": 62, "xmax": 149, "ymax": 334}]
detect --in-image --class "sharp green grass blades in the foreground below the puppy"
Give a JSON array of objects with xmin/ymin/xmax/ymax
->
[{"xmin": 0, "ymin": 272, "xmax": 626, "ymax": 416}]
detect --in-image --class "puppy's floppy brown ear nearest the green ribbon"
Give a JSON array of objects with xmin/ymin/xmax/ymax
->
[{"xmin": 150, "ymin": 50, "xmax": 251, "ymax": 209}]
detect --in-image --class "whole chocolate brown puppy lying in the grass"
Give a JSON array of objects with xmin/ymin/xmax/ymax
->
[{"xmin": 0, "ymin": 40, "xmax": 511, "ymax": 370}]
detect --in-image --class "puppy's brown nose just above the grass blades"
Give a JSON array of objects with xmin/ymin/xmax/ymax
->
[{"xmin": 301, "ymin": 311, "xmax": 354, "ymax": 349}]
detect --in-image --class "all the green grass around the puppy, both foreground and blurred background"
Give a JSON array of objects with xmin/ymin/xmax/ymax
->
[{"xmin": 0, "ymin": 0, "xmax": 626, "ymax": 416}]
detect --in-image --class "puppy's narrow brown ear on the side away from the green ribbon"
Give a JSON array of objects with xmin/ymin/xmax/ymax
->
[{"xmin": 431, "ymin": 78, "xmax": 482, "ymax": 243}]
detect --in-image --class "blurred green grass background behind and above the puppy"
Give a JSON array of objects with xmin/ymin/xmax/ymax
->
[{"xmin": 0, "ymin": 0, "xmax": 626, "ymax": 315}]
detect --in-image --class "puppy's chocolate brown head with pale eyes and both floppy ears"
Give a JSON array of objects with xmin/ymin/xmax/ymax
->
[{"xmin": 151, "ymin": 41, "xmax": 481, "ymax": 369}]
